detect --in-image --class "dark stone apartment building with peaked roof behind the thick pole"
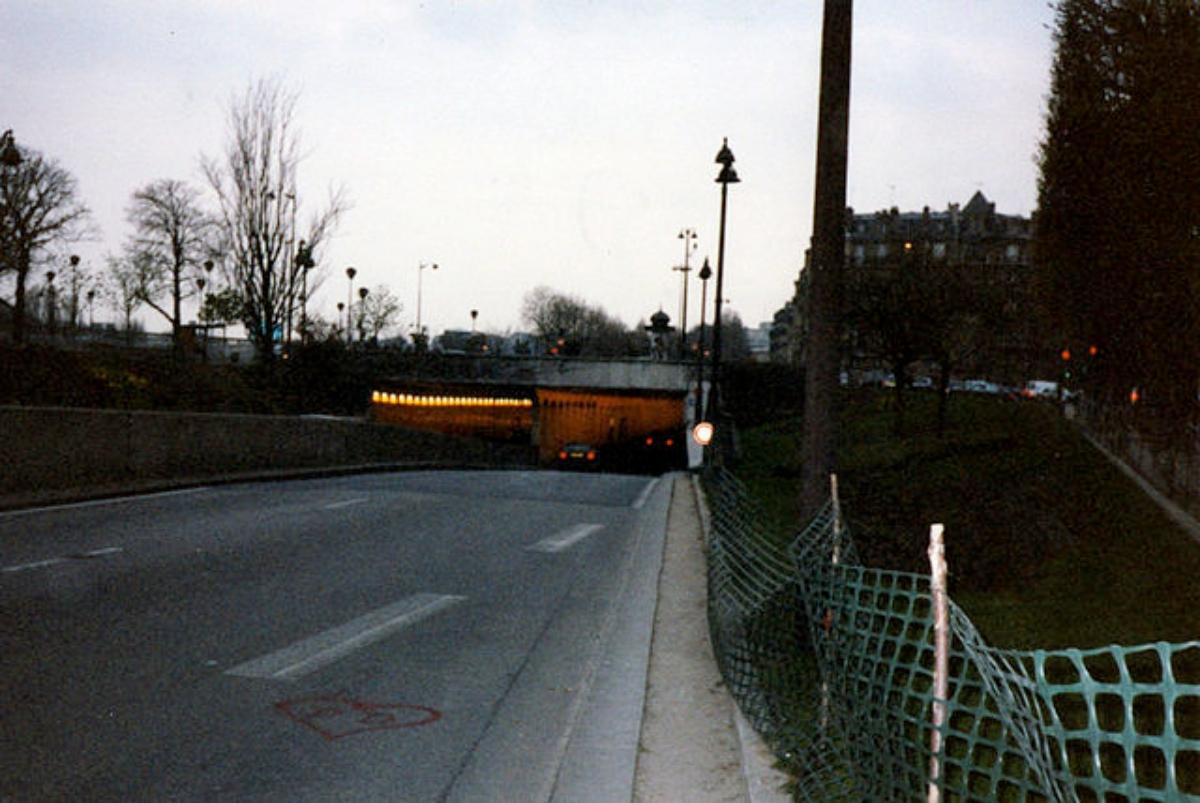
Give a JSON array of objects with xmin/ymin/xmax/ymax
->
[{"xmin": 772, "ymin": 192, "xmax": 1037, "ymax": 379}]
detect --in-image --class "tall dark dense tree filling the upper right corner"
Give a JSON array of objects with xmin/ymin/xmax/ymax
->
[{"xmin": 1037, "ymin": 0, "xmax": 1200, "ymax": 420}]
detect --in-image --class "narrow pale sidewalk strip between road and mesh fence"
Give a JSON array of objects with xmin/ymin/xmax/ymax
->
[{"xmin": 634, "ymin": 474, "xmax": 791, "ymax": 803}]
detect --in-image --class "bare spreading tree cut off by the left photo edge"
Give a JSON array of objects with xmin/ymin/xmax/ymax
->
[{"xmin": 0, "ymin": 140, "xmax": 91, "ymax": 343}]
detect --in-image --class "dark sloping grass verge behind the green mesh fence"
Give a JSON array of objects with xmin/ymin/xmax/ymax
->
[{"xmin": 736, "ymin": 392, "xmax": 1200, "ymax": 649}]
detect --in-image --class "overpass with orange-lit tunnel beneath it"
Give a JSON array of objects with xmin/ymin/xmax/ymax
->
[{"xmin": 370, "ymin": 358, "xmax": 696, "ymax": 468}]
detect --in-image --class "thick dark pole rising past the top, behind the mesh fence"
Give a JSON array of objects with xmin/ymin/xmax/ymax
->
[{"xmin": 800, "ymin": 0, "xmax": 853, "ymax": 517}]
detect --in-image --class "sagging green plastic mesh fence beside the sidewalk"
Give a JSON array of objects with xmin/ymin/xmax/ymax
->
[{"xmin": 704, "ymin": 468, "xmax": 1200, "ymax": 803}]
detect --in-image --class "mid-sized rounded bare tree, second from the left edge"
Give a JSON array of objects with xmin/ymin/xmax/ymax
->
[{"xmin": 125, "ymin": 179, "xmax": 212, "ymax": 349}]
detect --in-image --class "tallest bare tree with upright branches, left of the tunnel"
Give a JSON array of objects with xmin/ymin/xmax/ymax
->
[{"xmin": 203, "ymin": 79, "xmax": 348, "ymax": 361}]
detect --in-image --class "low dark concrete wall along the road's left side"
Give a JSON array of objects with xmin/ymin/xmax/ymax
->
[{"xmin": 0, "ymin": 406, "xmax": 533, "ymax": 493}]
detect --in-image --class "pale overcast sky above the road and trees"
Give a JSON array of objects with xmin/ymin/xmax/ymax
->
[{"xmin": 0, "ymin": 0, "xmax": 1052, "ymax": 332}]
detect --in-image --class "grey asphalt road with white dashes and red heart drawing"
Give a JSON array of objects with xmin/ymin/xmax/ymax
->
[{"xmin": 0, "ymin": 472, "xmax": 670, "ymax": 802}]
